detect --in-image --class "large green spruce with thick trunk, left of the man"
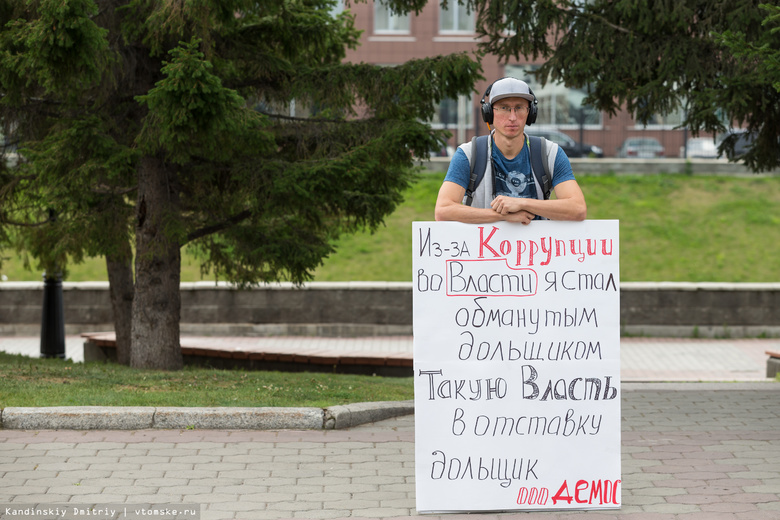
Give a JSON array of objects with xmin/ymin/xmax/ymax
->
[{"xmin": 0, "ymin": 0, "xmax": 480, "ymax": 369}]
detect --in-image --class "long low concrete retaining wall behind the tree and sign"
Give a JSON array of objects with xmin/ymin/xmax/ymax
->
[{"xmin": 0, "ymin": 282, "xmax": 780, "ymax": 337}]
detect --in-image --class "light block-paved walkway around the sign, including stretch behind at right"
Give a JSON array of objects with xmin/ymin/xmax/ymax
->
[{"xmin": 0, "ymin": 339, "xmax": 780, "ymax": 520}]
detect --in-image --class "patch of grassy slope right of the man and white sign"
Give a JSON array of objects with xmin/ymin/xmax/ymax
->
[{"xmin": 583, "ymin": 175, "xmax": 780, "ymax": 282}]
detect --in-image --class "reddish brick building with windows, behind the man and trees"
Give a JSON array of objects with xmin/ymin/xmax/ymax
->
[{"xmin": 347, "ymin": 0, "xmax": 687, "ymax": 157}]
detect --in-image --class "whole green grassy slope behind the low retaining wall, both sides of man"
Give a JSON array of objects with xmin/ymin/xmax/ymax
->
[{"xmin": 1, "ymin": 173, "xmax": 780, "ymax": 282}]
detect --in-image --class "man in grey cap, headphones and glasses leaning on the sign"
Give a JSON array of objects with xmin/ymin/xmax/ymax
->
[{"xmin": 435, "ymin": 78, "xmax": 587, "ymax": 225}]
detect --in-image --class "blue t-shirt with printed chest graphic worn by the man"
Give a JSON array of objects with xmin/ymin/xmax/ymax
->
[{"xmin": 444, "ymin": 137, "xmax": 574, "ymax": 199}]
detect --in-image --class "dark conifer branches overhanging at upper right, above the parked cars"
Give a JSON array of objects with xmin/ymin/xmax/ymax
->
[{"xmin": 477, "ymin": 0, "xmax": 780, "ymax": 171}]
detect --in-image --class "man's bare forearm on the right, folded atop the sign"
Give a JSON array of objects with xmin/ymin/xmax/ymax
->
[{"xmin": 491, "ymin": 180, "xmax": 588, "ymax": 221}]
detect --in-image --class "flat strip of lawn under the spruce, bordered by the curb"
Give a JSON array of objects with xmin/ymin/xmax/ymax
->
[{"xmin": 0, "ymin": 353, "xmax": 414, "ymax": 408}]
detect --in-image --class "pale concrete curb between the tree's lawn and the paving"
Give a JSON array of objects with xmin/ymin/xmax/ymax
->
[{"xmin": 0, "ymin": 401, "xmax": 414, "ymax": 430}]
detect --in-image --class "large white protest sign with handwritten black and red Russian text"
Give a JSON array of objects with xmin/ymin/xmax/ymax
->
[{"xmin": 413, "ymin": 220, "xmax": 621, "ymax": 512}]
